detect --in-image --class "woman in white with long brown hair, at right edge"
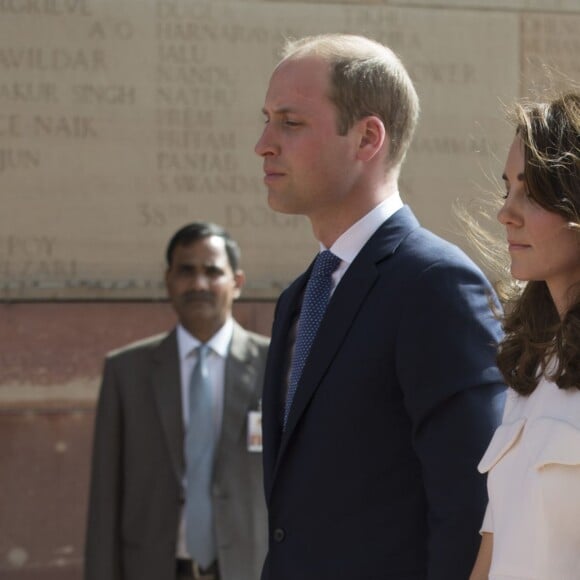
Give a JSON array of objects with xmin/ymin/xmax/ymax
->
[{"xmin": 470, "ymin": 92, "xmax": 580, "ymax": 580}]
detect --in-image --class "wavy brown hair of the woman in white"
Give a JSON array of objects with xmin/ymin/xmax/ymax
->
[{"xmin": 497, "ymin": 92, "xmax": 580, "ymax": 395}]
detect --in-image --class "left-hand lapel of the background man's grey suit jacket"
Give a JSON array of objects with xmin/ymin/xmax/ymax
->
[{"xmin": 151, "ymin": 330, "xmax": 185, "ymax": 484}]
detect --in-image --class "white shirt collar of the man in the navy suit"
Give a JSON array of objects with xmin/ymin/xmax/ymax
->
[{"xmin": 321, "ymin": 191, "xmax": 403, "ymax": 264}]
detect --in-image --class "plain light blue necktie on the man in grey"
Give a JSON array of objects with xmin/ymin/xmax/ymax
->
[{"xmin": 185, "ymin": 344, "xmax": 216, "ymax": 568}]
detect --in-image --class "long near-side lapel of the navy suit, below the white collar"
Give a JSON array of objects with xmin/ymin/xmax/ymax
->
[{"xmin": 272, "ymin": 206, "xmax": 419, "ymax": 479}]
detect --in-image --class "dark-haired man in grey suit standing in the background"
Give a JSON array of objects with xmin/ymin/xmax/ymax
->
[{"xmin": 85, "ymin": 223, "xmax": 268, "ymax": 580}]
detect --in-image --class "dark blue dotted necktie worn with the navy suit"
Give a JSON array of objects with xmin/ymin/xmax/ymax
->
[{"xmin": 284, "ymin": 250, "xmax": 340, "ymax": 428}]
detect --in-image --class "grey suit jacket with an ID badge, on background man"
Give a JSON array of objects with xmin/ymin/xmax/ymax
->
[{"xmin": 85, "ymin": 324, "xmax": 268, "ymax": 580}]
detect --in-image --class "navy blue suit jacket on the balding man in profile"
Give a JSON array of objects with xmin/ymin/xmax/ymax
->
[{"xmin": 262, "ymin": 207, "xmax": 504, "ymax": 580}]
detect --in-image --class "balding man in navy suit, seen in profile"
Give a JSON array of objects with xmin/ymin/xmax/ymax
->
[{"xmin": 256, "ymin": 35, "xmax": 504, "ymax": 580}]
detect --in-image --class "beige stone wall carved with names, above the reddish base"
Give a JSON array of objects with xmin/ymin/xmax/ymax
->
[{"xmin": 0, "ymin": 0, "xmax": 580, "ymax": 300}]
